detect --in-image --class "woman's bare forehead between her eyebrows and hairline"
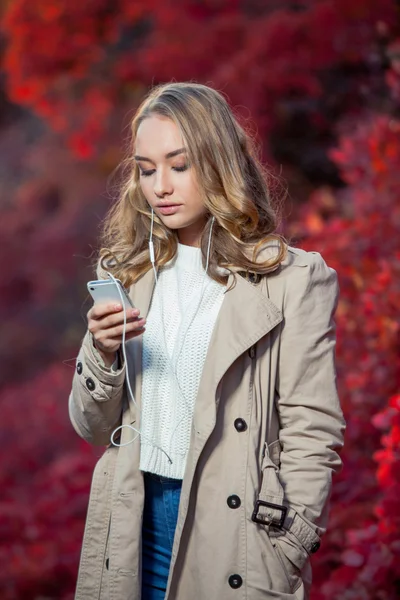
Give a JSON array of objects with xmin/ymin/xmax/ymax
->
[{"xmin": 135, "ymin": 115, "xmax": 184, "ymax": 158}]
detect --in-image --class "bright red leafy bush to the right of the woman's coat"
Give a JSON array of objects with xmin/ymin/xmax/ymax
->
[{"xmin": 292, "ymin": 116, "xmax": 400, "ymax": 600}]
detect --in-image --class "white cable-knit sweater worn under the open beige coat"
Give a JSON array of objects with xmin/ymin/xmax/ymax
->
[{"xmin": 140, "ymin": 244, "xmax": 226, "ymax": 479}]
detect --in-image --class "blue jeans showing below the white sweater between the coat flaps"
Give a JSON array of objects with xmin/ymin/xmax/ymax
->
[{"xmin": 142, "ymin": 473, "xmax": 182, "ymax": 600}]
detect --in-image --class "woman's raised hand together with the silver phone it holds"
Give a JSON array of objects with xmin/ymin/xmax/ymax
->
[{"xmin": 87, "ymin": 279, "xmax": 146, "ymax": 366}]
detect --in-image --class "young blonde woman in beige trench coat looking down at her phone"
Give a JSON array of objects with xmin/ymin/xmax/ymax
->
[{"xmin": 70, "ymin": 83, "xmax": 344, "ymax": 600}]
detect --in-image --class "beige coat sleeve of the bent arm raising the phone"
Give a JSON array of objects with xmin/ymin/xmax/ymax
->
[{"xmin": 68, "ymin": 267, "xmax": 126, "ymax": 445}]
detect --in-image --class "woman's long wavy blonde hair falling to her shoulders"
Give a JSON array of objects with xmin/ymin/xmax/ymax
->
[{"xmin": 99, "ymin": 83, "xmax": 286, "ymax": 286}]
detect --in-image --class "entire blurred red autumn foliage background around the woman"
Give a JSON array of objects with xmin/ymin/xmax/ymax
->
[{"xmin": 0, "ymin": 0, "xmax": 400, "ymax": 600}]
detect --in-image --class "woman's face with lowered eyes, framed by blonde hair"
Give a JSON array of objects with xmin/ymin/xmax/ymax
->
[{"xmin": 135, "ymin": 116, "xmax": 207, "ymax": 246}]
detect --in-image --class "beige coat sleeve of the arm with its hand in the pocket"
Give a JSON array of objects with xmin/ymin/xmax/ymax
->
[{"xmin": 277, "ymin": 252, "xmax": 345, "ymax": 535}]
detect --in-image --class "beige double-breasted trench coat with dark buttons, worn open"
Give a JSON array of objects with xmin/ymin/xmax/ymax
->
[{"xmin": 69, "ymin": 247, "xmax": 344, "ymax": 600}]
